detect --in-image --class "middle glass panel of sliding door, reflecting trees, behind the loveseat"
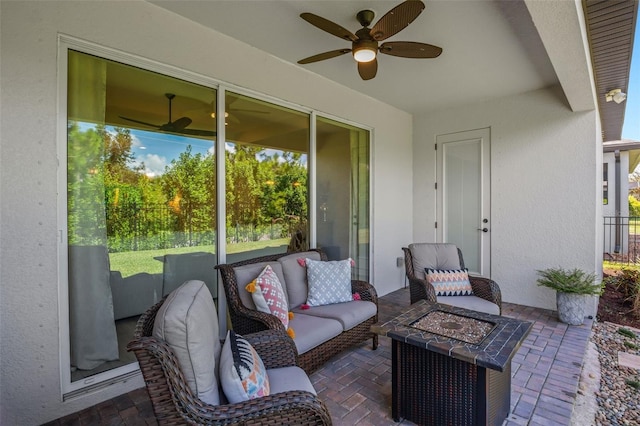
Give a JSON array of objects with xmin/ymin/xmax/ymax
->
[{"xmin": 225, "ymin": 92, "xmax": 310, "ymax": 263}]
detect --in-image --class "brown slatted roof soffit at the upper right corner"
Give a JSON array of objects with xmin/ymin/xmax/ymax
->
[{"xmin": 584, "ymin": 0, "xmax": 638, "ymax": 143}]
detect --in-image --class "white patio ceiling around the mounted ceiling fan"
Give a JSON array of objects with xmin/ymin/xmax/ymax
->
[{"xmin": 152, "ymin": 0, "xmax": 558, "ymax": 113}]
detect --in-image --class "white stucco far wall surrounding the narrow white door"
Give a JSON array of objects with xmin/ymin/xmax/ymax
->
[{"xmin": 413, "ymin": 88, "xmax": 602, "ymax": 309}]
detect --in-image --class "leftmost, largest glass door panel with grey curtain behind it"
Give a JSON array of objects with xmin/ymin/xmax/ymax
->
[{"xmin": 67, "ymin": 51, "xmax": 218, "ymax": 384}]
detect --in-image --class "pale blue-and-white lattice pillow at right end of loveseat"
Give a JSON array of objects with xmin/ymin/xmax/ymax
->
[{"xmin": 305, "ymin": 259, "xmax": 353, "ymax": 306}]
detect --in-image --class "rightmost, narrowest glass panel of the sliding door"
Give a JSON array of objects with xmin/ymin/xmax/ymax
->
[{"xmin": 316, "ymin": 117, "xmax": 369, "ymax": 281}]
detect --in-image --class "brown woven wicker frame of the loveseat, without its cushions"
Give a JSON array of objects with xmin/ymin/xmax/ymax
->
[{"xmin": 216, "ymin": 249, "xmax": 378, "ymax": 374}]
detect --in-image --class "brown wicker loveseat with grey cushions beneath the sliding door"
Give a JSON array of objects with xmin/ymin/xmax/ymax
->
[{"xmin": 216, "ymin": 249, "xmax": 378, "ymax": 373}]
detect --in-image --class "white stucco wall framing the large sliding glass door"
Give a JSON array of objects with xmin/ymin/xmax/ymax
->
[{"xmin": 0, "ymin": 1, "xmax": 413, "ymax": 425}]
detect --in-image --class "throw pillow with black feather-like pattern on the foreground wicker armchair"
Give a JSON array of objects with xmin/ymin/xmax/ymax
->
[{"xmin": 220, "ymin": 330, "xmax": 270, "ymax": 404}]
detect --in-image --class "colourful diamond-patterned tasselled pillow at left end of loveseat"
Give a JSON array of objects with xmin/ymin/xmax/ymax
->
[{"xmin": 246, "ymin": 265, "xmax": 289, "ymax": 330}]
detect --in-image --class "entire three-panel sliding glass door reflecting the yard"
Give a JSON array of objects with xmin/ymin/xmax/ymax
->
[{"xmin": 60, "ymin": 45, "xmax": 370, "ymax": 397}]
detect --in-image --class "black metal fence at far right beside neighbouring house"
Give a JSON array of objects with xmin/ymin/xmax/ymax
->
[{"xmin": 603, "ymin": 216, "xmax": 640, "ymax": 263}]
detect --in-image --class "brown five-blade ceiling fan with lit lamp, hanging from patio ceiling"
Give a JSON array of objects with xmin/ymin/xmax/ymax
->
[{"xmin": 298, "ymin": 0, "xmax": 442, "ymax": 80}]
